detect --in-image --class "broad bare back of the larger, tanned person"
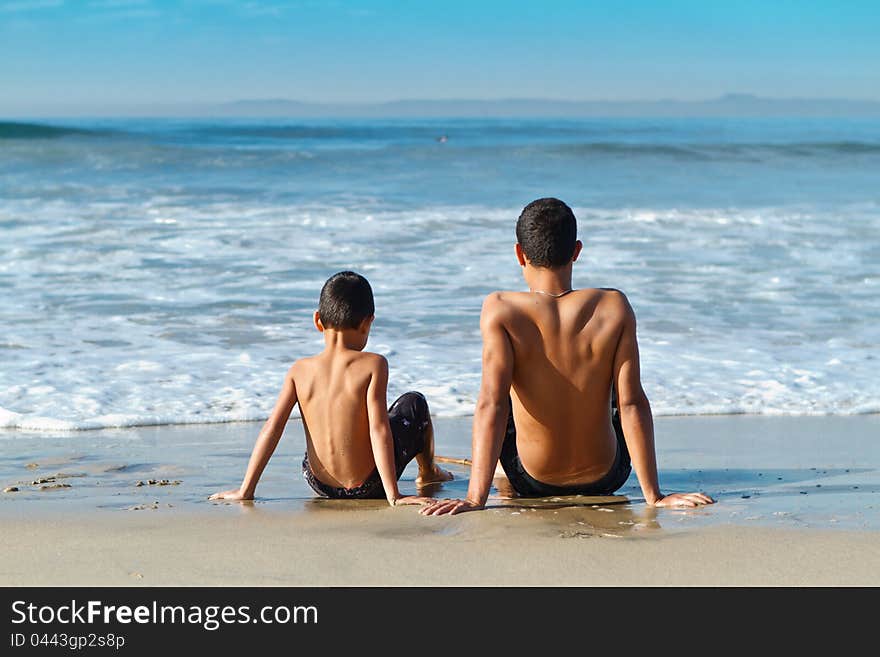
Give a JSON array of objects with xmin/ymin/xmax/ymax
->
[{"xmin": 491, "ymin": 289, "xmax": 628, "ymax": 486}]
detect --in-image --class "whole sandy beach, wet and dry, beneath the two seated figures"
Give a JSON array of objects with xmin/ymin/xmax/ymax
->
[{"xmin": 0, "ymin": 415, "xmax": 880, "ymax": 586}]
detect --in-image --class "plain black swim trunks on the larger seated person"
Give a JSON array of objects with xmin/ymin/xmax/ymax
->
[{"xmin": 501, "ymin": 390, "xmax": 632, "ymax": 497}]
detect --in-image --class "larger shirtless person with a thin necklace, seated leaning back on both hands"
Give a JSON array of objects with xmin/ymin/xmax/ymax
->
[{"xmin": 420, "ymin": 198, "xmax": 714, "ymax": 515}]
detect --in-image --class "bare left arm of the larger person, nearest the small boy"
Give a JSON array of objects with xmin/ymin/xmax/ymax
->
[{"xmin": 422, "ymin": 295, "xmax": 513, "ymax": 515}]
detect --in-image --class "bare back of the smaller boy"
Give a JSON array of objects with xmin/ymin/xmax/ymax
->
[{"xmin": 292, "ymin": 350, "xmax": 385, "ymax": 488}]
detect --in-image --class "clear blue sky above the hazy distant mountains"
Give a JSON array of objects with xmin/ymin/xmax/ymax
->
[{"xmin": 0, "ymin": 0, "xmax": 880, "ymax": 111}]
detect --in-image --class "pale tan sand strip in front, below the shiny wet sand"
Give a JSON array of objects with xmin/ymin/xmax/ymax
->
[{"xmin": 0, "ymin": 506, "xmax": 880, "ymax": 586}]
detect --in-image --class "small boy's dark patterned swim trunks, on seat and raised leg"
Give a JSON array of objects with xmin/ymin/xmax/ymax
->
[{"xmin": 303, "ymin": 392, "xmax": 431, "ymax": 499}]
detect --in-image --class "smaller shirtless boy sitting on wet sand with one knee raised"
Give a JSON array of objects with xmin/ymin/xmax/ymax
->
[{"xmin": 209, "ymin": 271, "xmax": 452, "ymax": 506}]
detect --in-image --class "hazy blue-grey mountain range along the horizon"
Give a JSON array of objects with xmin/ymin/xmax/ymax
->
[{"xmin": 6, "ymin": 94, "xmax": 880, "ymax": 118}]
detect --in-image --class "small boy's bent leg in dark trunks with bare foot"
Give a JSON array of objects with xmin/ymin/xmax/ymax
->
[{"xmin": 388, "ymin": 392, "xmax": 452, "ymax": 485}]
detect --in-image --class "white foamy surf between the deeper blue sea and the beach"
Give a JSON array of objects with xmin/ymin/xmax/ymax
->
[{"xmin": 0, "ymin": 195, "xmax": 880, "ymax": 432}]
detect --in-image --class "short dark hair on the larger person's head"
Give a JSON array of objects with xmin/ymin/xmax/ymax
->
[{"xmin": 516, "ymin": 198, "xmax": 577, "ymax": 267}]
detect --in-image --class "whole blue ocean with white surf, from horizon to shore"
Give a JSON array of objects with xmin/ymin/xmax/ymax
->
[{"xmin": 0, "ymin": 119, "xmax": 880, "ymax": 433}]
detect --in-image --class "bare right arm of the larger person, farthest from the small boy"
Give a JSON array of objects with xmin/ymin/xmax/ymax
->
[{"xmin": 613, "ymin": 294, "xmax": 713, "ymax": 506}]
